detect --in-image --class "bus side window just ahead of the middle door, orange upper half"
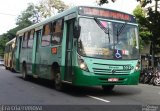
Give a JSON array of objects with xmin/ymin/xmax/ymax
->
[{"xmin": 41, "ymin": 23, "xmax": 51, "ymax": 46}]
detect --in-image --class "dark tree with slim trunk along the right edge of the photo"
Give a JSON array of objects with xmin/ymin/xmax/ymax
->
[{"xmin": 137, "ymin": 0, "xmax": 160, "ymax": 67}]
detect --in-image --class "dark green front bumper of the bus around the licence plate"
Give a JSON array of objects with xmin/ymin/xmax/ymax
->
[{"xmin": 72, "ymin": 67, "xmax": 140, "ymax": 86}]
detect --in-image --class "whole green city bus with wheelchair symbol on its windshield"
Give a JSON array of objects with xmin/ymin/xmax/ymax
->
[{"xmin": 15, "ymin": 6, "xmax": 140, "ymax": 91}]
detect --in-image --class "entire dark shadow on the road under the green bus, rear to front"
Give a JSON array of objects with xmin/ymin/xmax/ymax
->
[{"xmin": 17, "ymin": 76, "xmax": 141, "ymax": 97}]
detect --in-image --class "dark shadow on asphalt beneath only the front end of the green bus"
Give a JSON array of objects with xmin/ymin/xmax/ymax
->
[{"xmin": 62, "ymin": 86, "xmax": 141, "ymax": 97}]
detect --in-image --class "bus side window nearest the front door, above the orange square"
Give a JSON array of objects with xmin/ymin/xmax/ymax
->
[{"xmin": 51, "ymin": 19, "xmax": 63, "ymax": 45}]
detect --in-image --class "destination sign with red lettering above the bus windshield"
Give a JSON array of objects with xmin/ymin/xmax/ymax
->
[{"xmin": 79, "ymin": 7, "xmax": 135, "ymax": 22}]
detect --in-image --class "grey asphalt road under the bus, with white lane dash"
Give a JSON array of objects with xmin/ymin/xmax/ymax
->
[{"xmin": 0, "ymin": 66, "xmax": 160, "ymax": 111}]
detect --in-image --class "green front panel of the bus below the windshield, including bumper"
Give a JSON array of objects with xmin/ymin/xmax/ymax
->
[{"xmin": 70, "ymin": 57, "xmax": 140, "ymax": 86}]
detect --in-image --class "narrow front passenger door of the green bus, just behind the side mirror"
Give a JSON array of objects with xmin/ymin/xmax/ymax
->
[{"xmin": 64, "ymin": 19, "xmax": 74, "ymax": 82}]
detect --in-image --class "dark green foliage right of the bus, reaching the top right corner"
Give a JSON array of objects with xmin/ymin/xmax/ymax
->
[{"xmin": 135, "ymin": 0, "xmax": 160, "ymax": 56}]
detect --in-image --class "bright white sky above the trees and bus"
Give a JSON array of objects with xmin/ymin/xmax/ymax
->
[{"xmin": 0, "ymin": 0, "xmax": 138, "ymax": 34}]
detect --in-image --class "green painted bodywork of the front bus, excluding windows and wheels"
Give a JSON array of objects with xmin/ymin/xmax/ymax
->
[{"xmin": 13, "ymin": 7, "xmax": 140, "ymax": 86}]
